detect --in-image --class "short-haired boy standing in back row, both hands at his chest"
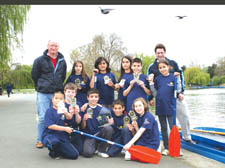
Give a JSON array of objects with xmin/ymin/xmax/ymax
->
[{"xmin": 123, "ymin": 58, "xmax": 150, "ymax": 111}]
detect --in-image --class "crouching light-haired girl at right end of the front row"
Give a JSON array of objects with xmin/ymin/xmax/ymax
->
[{"xmin": 124, "ymin": 97, "xmax": 160, "ymax": 160}]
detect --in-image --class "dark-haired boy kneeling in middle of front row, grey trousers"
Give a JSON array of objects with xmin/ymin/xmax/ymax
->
[{"xmin": 82, "ymin": 88, "xmax": 113, "ymax": 158}]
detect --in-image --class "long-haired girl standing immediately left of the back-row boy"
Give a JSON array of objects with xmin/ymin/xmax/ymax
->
[{"xmin": 115, "ymin": 56, "xmax": 132, "ymax": 108}]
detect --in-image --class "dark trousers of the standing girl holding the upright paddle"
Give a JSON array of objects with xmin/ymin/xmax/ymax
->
[{"xmin": 158, "ymin": 115, "xmax": 173, "ymax": 149}]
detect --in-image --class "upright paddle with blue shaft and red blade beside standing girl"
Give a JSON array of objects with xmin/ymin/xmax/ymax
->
[{"xmin": 169, "ymin": 77, "xmax": 181, "ymax": 157}]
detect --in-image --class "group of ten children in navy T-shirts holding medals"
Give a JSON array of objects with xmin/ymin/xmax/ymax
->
[{"xmin": 42, "ymin": 56, "xmax": 182, "ymax": 160}]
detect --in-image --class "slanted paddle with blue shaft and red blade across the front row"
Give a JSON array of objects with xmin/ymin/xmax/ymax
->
[{"xmin": 73, "ymin": 130, "xmax": 161, "ymax": 164}]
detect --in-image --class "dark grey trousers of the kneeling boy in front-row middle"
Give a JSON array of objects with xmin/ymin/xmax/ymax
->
[{"xmin": 83, "ymin": 126, "xmax": 114, "ymax": 157}]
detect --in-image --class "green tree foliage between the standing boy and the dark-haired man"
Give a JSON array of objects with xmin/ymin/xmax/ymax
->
[{"xmin": 136, "ymin": 53, "xmax": 155, "ymax": 74}]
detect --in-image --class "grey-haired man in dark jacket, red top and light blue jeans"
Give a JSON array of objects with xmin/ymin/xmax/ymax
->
[{"xmin": 31, "ymin": 40, "xmax": 67, "ymax": 148}]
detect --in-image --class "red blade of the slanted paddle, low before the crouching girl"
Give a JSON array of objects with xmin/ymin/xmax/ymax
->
[{"xmin": 128, "ymin": 145, "xmax": 161, "ymax": 164}]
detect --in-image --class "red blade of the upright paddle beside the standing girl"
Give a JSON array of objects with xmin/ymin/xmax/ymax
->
[{"xmin": 169, "ymin": 125, "xmax": 181, "ymax": 157}]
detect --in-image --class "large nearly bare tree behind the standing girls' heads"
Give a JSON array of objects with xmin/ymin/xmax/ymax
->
[{"xmin": 70, "ymin": 33, "xmax": 127, "ymax": 74}]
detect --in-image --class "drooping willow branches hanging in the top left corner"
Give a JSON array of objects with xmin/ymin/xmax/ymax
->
[{"xmin": 0, "ymin": 5, "xmax": 30, "ymax": 84}]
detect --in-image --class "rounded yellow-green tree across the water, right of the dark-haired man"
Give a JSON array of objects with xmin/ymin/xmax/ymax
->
[{"xmin": 184, "ymin": 67, "xmax": 210, "ymax": 86}]
